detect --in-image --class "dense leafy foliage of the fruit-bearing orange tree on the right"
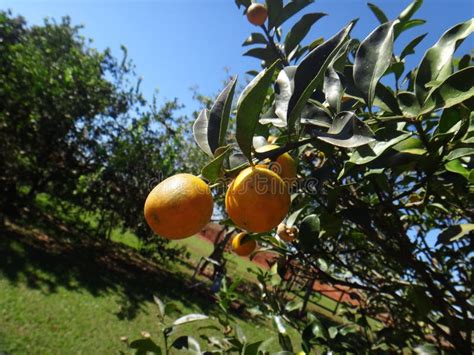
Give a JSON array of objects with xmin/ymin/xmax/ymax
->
[{"xmin": 183, "ymin": 0, "xmax": 474, "ymax": 354}]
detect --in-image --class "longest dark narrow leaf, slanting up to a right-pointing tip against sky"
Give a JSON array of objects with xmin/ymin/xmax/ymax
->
[{"xmin": 287, "ymin": 21, "xmax": 355, "ymax": 131}]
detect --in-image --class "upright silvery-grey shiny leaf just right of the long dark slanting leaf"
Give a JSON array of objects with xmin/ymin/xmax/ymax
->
[{"xmin": 353, "ymin": 22, "xmax": 396, "ymax": 108}]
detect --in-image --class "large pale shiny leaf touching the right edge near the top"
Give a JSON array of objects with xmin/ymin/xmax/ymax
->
[{"xmin": 415, "ymin": 19, "xmax": 474, "ymax": 105}]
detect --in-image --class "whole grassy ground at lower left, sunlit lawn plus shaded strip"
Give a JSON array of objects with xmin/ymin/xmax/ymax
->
[{"xmin": 0, "ymin": 222, "xmax": 304, "ymax": 354}]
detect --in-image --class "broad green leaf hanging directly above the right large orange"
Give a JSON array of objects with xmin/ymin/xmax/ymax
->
[{"xmin": 236, "ymin": 61, "xmax": 280, "ymax": 160}]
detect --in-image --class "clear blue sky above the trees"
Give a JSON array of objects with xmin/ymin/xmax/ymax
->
[{"xmin": 0, "ymin": 0, "xmax": 474, "ymax": 113}]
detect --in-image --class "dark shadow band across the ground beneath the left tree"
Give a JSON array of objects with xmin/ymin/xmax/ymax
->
[{"xmin": 0, "ymin": 216, "xmax": 243, "ymax": 319}]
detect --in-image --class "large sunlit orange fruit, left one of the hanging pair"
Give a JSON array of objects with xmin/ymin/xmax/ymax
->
[{"xmin": 144, "ymin": 174, "xmax": 214, "ymax": 239}]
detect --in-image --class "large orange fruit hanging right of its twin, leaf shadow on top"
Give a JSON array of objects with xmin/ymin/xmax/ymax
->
[{"xmin": 225, "ymin": 166, "xmax": 291, "ymax": 233}]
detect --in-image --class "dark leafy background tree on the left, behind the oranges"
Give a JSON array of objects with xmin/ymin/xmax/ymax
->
[{"xmin": 0, "ymin": 12, "xmax": 204, "ymax": 250}]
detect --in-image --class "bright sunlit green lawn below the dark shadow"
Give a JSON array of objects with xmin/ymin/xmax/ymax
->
[{"xmin": 0, "ymin": 279, "xmax": 282, "ymax": 354}]
